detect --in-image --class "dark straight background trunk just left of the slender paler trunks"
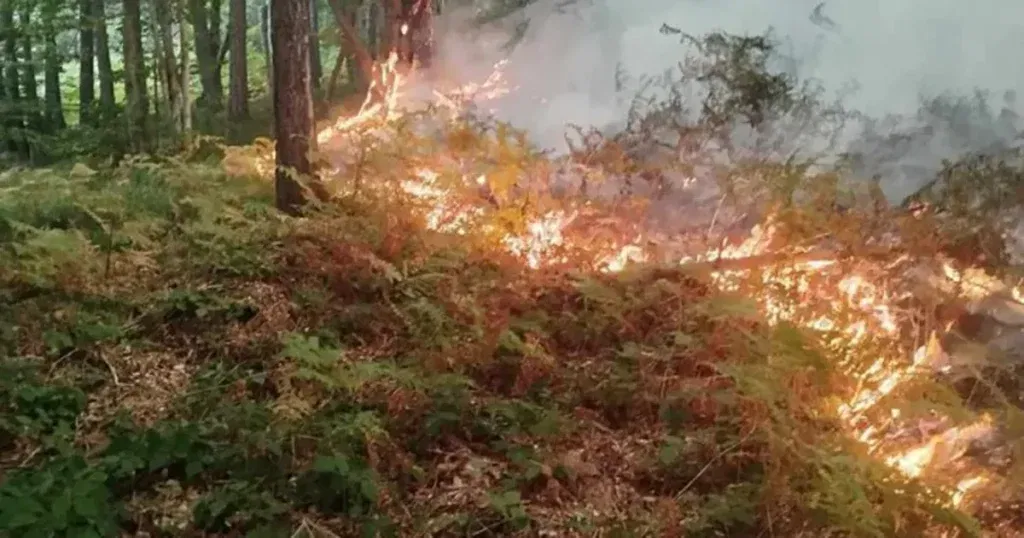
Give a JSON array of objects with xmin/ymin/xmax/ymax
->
[{"xmin": 123, "ymin": 0, "xmax": 150, "ymax": 153}]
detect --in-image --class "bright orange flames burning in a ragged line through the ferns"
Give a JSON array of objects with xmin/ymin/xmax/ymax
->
[{"xmin": 278, "ymin": 49, "xmax": 1021, "ymax": 516}]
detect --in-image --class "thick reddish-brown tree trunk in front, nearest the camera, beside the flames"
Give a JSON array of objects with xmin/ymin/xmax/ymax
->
[{"xmin": 271, "ymin": 0, "xmax": 315, "ymax": 215}]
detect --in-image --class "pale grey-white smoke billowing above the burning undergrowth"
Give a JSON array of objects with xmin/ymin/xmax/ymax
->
[{"xmin": 428, "ymin": 0, "xmax": 1024, "ymax": 202}]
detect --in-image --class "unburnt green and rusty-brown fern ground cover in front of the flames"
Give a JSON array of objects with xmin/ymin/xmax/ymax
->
[{"xmin": 0, "ymin": 155, "xmax": 999, "ymax": 538}]
